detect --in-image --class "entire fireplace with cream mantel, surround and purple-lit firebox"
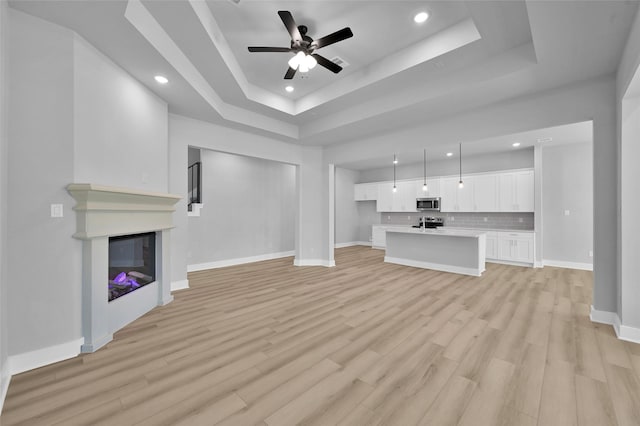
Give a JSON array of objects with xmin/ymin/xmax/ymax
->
[{"xmin": 67, "ymin": 183, "xmax": 180, "ymax": 352}]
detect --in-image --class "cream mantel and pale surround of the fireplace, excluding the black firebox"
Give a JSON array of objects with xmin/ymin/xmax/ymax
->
[{"xmin": 67, "ymin": 183, "xmax": 181, "ymax": 352}]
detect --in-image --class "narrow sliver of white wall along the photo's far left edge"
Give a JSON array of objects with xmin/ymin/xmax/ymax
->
[{"xmin": 0, "ymin": 0, "xmax": 10, "ymax": 413}]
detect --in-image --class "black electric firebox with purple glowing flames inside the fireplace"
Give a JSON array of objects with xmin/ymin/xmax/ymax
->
[{"xmin": 108, "ymin": 232, "xmax": 156, "ymax": 302}]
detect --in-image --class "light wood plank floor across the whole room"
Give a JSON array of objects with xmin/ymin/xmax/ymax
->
[{"xmin": 0, "ymin": 247, "xmax": 640, "ymax": 426}]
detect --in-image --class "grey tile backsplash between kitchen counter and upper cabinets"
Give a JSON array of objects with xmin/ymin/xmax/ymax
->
[{"xmin": 380, "ymin": 212, "xmax": 534, "ymax": 230}]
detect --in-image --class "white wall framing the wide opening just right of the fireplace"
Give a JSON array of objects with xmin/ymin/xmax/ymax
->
[{"xmin": 169, "ymin": 114, "xmax": 328, "ymax": 283}]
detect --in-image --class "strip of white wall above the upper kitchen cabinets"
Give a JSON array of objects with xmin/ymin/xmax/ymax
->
[{"xmin": 359, "ymin": 148, "xmax": 534, "ymax": 183}]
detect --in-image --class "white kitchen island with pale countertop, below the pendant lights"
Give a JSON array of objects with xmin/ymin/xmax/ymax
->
[{"xmin": 384, "ymin": 228, "xmax": 487, "ymax": 277}]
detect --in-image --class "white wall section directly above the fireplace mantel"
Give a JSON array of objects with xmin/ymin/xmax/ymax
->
[{"xmin": 73, "ymin": 36, "xmax": 169, "ymax": 193}]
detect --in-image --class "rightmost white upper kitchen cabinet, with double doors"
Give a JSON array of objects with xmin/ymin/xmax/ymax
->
[{"xmin": 498, "ymin": 170, "xmax": 534, "ymax": 212}]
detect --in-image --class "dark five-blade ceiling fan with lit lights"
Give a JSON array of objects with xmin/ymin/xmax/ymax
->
[{"xmin": 248, "ymin": 10, "xmax": 353, "ymax": 80}]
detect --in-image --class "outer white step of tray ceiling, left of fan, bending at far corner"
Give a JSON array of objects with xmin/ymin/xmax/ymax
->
[{"xmin": 124, "ymin": 0, "xmax": 299, "ymax": 139}]
